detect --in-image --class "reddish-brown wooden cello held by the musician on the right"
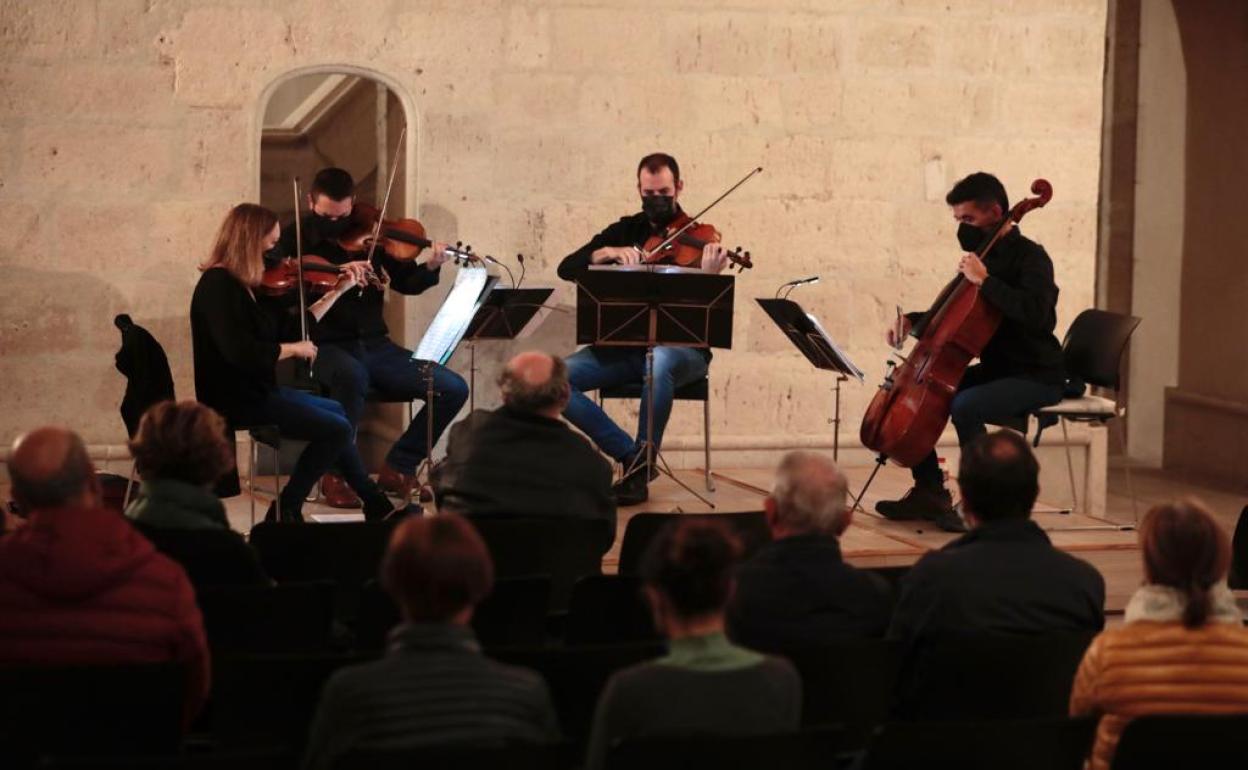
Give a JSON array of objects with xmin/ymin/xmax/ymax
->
[{"xmin": 855, "ymin": 180, "xmax": 1053, "ymax": 469}]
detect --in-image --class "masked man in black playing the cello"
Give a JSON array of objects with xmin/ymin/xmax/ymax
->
[{"xmin": 875, "ymin": 171, "xmax": 1066, "ymax": 532}]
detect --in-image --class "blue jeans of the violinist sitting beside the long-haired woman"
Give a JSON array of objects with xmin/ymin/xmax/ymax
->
[{"xmin": 313, "ymin": 339, "xmax": 468, "ymax": 474}]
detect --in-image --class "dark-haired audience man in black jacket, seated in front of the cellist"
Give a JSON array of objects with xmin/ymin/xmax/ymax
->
[{"xmin": 889, "ymin": 431, "xmax": 1104, "ymax": 713}]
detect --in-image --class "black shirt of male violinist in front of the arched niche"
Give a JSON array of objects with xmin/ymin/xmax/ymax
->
[{"xmin": 276, "ymin": 215, "xmax": 439, "ymax": 344}]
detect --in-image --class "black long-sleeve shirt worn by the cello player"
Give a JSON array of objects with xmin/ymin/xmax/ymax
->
[{"xmin": 907, "ymin": 227, "xmax": 1066, "ymax": 384}]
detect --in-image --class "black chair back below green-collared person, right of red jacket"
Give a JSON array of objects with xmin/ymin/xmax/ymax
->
[{"xmin": 198, "ymin": 580, "xmax": 336, "ymax": 654}]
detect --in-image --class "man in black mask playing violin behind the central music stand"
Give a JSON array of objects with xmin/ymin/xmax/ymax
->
[{"xmin": 559, "ymin": 152, "xmax": 729, "ymax": 505}]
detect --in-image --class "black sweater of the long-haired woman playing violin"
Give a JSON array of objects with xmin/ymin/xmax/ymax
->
[{"xmin": 191, "ymin": 267, "xmax": 281, "ymax": 426}]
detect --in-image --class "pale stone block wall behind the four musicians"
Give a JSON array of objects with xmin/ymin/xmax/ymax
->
[{"xmin": 0, "ymin": 0, "xmax": 1106, "ymax": 464}]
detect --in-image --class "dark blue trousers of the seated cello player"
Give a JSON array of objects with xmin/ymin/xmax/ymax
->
[{"xmin": 910, "ymin": 364, "xmax": 1063, "ymax": 487}]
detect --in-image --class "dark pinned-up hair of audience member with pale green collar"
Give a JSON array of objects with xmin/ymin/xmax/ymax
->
[{"xmin": 641, "ymin": 519, "xmax": 741, "ymax": 619}]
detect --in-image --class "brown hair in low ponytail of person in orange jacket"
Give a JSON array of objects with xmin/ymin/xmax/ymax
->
[{"xmin": 1139, "ymin": 499, "xmax": 1231, "ymax": 628}]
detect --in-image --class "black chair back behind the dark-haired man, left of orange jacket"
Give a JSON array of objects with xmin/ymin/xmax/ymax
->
[{"xmin": 900, "ymin": 633, "xmax": 1093, "ymax": 720}]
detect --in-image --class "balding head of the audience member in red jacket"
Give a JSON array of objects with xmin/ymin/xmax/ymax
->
[{"xmin": 9, "ymin": 427, "xmax": 99, "ymax": 512}]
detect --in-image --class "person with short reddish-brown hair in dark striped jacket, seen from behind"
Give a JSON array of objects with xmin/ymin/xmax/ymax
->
[{"xmin": 305, "ymin": 514, "xmax": 559, "ymax": 770}]
